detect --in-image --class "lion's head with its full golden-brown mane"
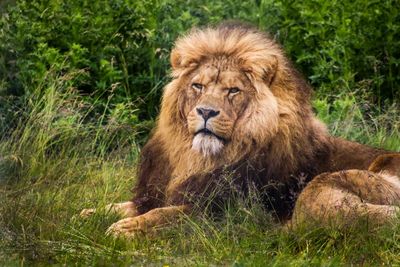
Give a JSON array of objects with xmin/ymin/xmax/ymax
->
[{"xmin": 158, "ymin": 24, "xmax": 324, "ymax": 176}]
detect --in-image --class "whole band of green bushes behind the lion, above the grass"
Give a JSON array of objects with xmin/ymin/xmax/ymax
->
[{"xmin": 0, "ymin": 0, "xmax": 400, "ymax": 137}]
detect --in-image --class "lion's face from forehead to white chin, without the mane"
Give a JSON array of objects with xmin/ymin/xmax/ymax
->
[{"xmin": 185, "ymin": 64, "xmax": 252, "ymax": 156}]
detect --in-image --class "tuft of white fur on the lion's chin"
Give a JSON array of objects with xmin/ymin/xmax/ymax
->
[{"xmin": 192, "ymin": 133, "xmax": 224, "ymax": 157}]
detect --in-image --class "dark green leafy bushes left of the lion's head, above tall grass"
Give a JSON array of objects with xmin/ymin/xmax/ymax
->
[{"xmin": 0, "ymin": 0, "xmax": 159, "ymax": 134}]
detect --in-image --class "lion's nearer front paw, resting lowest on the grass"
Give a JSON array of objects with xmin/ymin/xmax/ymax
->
[{"xmin": 106, "ymin": 217, "xmax": 145, "ymax": 238}]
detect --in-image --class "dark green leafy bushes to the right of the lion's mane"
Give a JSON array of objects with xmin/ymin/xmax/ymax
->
[{"xmin": 259, "ymin": 0, "xmax": 400, "ymax": 102}]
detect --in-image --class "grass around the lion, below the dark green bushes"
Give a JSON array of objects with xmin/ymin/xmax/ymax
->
[{"xmin": 0, "ymin": 74, "xmax": 400, "ymax": 266}]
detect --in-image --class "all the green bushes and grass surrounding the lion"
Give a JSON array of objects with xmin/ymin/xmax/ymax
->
[{"xmin": 0, "ymin": 0, "xmax": 400, "ymax": 266}]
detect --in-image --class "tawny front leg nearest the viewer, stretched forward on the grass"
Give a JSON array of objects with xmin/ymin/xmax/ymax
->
[{"xmin": 106, "ymin": 205, "xmax": 191, "ymax": 237}]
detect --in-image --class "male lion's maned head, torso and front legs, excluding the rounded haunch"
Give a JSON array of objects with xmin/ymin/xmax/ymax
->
[{"xmin": 82, "ymin": 23, "xmax": 396, "ymax": 236}]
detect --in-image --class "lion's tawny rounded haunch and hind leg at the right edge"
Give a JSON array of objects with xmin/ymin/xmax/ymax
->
[{"xmin": 287, "ymin": 154, "xmax": 400, "ymax": 228}]
